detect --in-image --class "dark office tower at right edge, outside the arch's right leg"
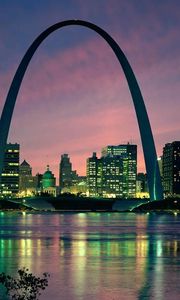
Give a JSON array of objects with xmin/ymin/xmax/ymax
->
[{"xmin": 162, "ymin": 141, "xmax": 180, "ymax": 196}]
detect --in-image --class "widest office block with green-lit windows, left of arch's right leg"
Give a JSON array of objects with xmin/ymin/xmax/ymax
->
[{"xmin": 87, "ymin": 144, "xmax": 137, "ymax": 198}]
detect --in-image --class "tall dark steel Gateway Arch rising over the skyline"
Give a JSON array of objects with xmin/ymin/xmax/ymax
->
[{"xmin": 0, "ymin": 20, "xmax": 163, "ymax": 200}]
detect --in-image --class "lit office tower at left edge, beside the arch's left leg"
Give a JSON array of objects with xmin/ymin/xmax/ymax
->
[{"xmin": 0, "ymin": 144, "xmax": 20, "ymax": 196}]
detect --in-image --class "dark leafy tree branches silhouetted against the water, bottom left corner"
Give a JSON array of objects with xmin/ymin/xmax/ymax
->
[{"xmin": 0, "ymin": 268, "xmax": 50, "ymax": 300}]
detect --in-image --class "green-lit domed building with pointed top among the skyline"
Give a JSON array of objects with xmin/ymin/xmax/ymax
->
[{"xmin": 42, "ymin": 165, "xmax": 56, "ymax": 196}]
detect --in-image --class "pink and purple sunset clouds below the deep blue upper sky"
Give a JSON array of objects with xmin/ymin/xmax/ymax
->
[{"xmin": 0, "ymin": 1, "xmax": 180, "ymax": 178}]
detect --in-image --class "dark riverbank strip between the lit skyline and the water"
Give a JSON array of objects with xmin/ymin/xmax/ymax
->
[{"xmin": 0, "ymin": 196, "xmax": 180, "ymax": 213}]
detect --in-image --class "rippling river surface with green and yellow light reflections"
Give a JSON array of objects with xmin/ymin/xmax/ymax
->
[{"xmin": 0, "ymin": 213, "xmax": 180, "ymax": 300}]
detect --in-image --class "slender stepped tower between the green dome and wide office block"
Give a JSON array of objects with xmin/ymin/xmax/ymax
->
[{"xmin": 59, "ymin": 154, "xmax": 78, "ymax": 189}]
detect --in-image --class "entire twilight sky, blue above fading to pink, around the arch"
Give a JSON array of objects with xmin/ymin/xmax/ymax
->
[{"xmin": 0, "ymin": 0, "xmax": 180, "ymax": 177}]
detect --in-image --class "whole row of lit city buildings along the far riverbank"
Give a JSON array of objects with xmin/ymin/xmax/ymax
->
[{"xmin": 1, "ymin": 141, "xmax": 180, "ymax": 199}]
